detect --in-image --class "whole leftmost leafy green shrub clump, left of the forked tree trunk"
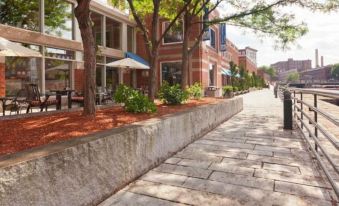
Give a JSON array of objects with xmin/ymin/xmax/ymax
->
[{"xmin": 114, "ymin": 85, "xmax": 157, "ymax": 113}]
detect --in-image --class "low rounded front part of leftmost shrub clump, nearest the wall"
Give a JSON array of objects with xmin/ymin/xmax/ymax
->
[{"xmin": 125, "ymin": 92, "xmax": 157, "ymax": 113}]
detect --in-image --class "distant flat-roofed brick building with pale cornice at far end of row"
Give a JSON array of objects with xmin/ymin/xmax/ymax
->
[{"xmin": 239, "ymin": 47, "xmax": 258, "ymax": 73}]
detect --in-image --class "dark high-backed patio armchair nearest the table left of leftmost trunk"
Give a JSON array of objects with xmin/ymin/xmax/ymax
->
[{"xmin": 25, "ymin": 84, "xmax": 58, "ymax": 113}]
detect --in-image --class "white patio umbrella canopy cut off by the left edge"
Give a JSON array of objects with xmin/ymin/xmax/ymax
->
[{"xmin": 0, "ymin": 37, "xmax": 42, "ymax": 57}]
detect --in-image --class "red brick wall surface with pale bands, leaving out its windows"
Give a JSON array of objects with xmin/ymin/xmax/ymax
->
[{"xmin": 137, "ymin": 12, "xmax": 238, "ymax": 97}]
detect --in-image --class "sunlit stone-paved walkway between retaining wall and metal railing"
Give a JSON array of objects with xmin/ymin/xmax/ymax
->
[{"xmin": 100, "ymin": 90, "xmax": 335, "ymax": 206}]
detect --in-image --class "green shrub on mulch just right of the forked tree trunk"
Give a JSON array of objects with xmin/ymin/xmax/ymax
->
[{"xmin": 158, "ymin": 81, "xmax": 189, "ymax": 104}]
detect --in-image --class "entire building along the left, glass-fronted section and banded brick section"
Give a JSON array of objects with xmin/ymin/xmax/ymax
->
[{"xmin": 0, "ymin": 0, "xmax": 258, "ymax": 99}]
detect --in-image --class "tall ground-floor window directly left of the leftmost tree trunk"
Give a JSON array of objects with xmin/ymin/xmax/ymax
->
[{"xmin": 45, "ymin": 48, "xmax": 74, "ymax": 91}]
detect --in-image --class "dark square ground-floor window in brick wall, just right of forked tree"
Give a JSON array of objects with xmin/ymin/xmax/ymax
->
[{"xmin": 161, "ymin": 62, "xmax": 181, "ymax": 85}]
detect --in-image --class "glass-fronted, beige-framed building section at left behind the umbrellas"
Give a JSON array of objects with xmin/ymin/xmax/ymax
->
[{"xmin": 0, "ymin": 0, "xmax": 136, "ymax": 96}]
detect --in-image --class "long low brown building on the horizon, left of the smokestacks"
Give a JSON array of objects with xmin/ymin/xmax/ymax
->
[{"xmin": 271, "ymin": 58, "xmax": 312, "ymax": 75}]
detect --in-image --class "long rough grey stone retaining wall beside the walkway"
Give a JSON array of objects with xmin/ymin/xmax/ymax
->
[{"xmin": 0, "ymin": 97, "xmax": 243, "ymax": 206}]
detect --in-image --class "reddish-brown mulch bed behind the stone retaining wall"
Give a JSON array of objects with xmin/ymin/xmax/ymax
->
[{"xmin": 0, "ymin": 98, "xmax": 220, "ymax": 156}]
